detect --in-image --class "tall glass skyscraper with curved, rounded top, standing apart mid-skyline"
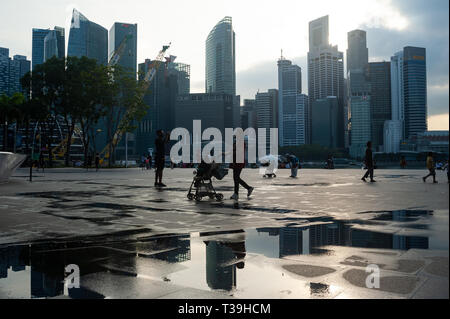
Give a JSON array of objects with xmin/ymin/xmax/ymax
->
[{"xmin": 205, "ymin": 17, "xmax": 236, "ymax": 95}]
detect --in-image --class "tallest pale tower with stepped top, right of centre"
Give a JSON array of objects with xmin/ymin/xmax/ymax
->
[{"xmin": 308, "ymin": 16, "xmax": 347, "ymax": 147}]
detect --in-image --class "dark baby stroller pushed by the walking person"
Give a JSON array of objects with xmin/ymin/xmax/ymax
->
[{"xmin": 187, "ymin": 161, "xmax": 228, "ymax": 202}]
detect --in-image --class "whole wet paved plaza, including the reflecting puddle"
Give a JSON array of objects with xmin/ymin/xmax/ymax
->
[{"xmin": 0, "ymin": 169, "xmax": 449, "ymax": 299}]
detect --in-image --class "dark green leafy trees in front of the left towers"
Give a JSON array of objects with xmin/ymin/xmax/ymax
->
[{"xmin": 14, "ymin": 57, "xmax": 146, "ymax": 165}]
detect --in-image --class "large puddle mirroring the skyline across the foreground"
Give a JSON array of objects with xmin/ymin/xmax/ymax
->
[{"xmin": 0, "ymin": 211, "xmax": 448, "ymax": 299}]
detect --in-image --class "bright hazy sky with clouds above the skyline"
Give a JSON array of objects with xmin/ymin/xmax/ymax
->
[{"xmin": 0, "ymin": 0, "xmax": 449, "ymax": 130}]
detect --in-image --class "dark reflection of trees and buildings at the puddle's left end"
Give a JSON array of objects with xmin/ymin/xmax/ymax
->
[{"xmin": 0, "ymin": 235, "xmax": 191, "ymax": 298}]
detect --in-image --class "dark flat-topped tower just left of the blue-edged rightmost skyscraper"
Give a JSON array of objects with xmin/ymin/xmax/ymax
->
[{"xmin": 368, "ymin": 62, "xmax": 392, "ymax": 151}]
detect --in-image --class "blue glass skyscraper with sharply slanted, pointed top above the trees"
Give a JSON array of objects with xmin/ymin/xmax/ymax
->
[{"xmin": 67, "ymin": 9, "xmax": 108, "ymax": 65}]
